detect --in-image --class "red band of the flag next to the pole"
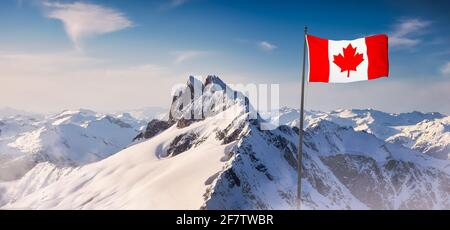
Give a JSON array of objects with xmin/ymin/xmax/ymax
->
[{"xmin": 306, "ymin": 35, "xmax": 330, "ymax": 82}]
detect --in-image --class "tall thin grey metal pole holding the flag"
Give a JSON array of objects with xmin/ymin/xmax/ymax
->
[{"xmin": 297, "ymin": 26, "xmax": 308, "ymax": 210}]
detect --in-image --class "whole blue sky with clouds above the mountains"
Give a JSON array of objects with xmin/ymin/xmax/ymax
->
[{"xmin": 0, "ymin": 0, "xmax": 450, "ymax": 113}]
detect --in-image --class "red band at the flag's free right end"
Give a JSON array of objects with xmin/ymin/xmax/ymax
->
[{"xmin": 366, "ymin": 34, "xmax": 389, "ymax": 80}]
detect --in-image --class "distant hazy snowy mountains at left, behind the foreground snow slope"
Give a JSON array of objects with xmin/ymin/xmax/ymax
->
[{"xmin": 0, "ymin": 110, "xmax": 144, "ymax": 181}]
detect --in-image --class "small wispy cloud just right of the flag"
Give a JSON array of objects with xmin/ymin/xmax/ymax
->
[{"xmin": 389, "ymin": 18, "xmax": 431, "ymax": 47}]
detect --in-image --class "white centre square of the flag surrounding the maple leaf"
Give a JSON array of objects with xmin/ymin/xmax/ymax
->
[{"xmin": 328, "ymin": 38, "xmax": 369, "ymax": 83}]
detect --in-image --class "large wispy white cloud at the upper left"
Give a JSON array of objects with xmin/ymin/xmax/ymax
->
[{"xmin": 43, "ymin": 1, "xmax": 133, "ymax": 49}]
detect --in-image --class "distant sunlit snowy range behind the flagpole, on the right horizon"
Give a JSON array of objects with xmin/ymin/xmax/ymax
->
[{"xmin": 269, "ymin": 107, "xmax": 450, "ymax": 159}]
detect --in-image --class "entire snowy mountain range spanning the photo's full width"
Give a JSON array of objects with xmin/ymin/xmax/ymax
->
[{"xmin": 0, "ymin": 76, "xmax": 450, "ymax": 209}]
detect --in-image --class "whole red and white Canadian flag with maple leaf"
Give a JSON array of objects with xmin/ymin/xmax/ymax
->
[{"xmin": 306, "ymin": 34, "xmax": 389, "ymax": 83}]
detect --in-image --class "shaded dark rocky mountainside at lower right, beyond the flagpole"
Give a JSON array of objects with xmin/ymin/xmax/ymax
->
[{"xmin": 322, "ymin": 154, "xmax": 450, "ymax": 209}]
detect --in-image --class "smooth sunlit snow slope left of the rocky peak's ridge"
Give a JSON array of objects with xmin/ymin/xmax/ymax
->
[{"xmin": 0, "ymin": 104, "xmax": 246, "ymax": 209}]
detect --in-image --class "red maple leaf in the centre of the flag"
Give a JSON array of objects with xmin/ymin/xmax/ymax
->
[{"xmin": 333, "ymin": 44, "xmax": 364, "ymax": 77}]
